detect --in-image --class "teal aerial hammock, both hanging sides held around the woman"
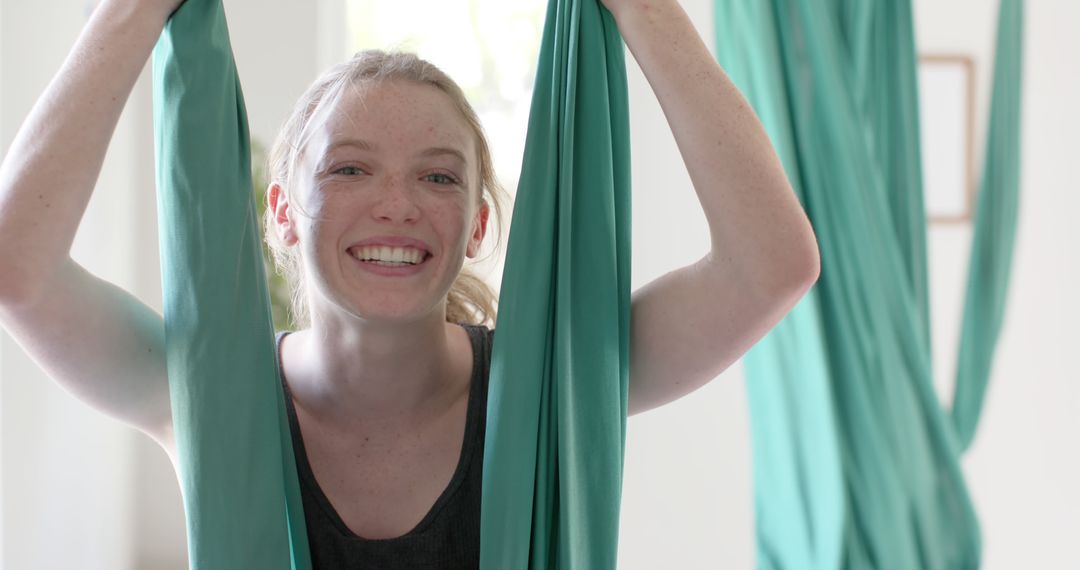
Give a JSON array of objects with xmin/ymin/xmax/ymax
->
[{"xmin": 153, "ymin": 0, "xmax": 630, "ymax": 570}]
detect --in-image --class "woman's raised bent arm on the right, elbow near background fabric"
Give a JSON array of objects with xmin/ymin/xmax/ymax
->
[{"xmin": 603, "ymin": 0, "xmax": 819, "ymax": 413}]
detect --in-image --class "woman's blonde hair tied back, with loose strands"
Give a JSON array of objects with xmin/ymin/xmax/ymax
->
[{"xmin": 264, "ymin": 50, "xmax": 507, "ymax": 328}]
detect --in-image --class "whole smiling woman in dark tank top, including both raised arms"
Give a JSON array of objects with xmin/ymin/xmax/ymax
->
[{"xmin": 0, "ymin": 0, "xmax": 819, "ymax": 568}]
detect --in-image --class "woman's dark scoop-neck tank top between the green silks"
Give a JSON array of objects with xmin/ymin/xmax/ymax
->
[{"xmin": 276, "ymin": 325, "xmax": 494, "ymax": 570}]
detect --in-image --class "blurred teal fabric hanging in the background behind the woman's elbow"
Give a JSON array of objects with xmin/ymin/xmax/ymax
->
[{"xmin": 716, "ymin": 0, "xmax": 1023, "ymax": 569}]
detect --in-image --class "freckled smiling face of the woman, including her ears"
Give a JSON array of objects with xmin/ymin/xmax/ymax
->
[{"xmin": 289, "ymin": 81, "xmax": 487, "ymax": 322}]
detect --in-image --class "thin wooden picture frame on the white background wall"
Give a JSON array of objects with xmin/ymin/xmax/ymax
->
[{"xmin": 919, "ymin": 54, "xmax": 976, "ymax": 225}]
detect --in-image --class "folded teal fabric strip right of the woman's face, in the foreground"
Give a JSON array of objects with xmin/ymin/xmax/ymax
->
[{"xmin": 481, "ymin": 0, "xmax": 630, "ymax": 570}]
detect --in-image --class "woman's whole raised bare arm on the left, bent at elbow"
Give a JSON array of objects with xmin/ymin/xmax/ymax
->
[{"xmin": 0, "ymin": 0, "xmax": 181, "ymax": 453}]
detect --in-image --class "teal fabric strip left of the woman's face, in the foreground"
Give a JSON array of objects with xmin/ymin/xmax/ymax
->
[{"xmin": 153, "ymin": 0, "xmax": 311, "ymax": 570}]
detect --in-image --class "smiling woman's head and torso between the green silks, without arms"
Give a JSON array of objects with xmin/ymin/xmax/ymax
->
[{"xmin": 257, "ymin": 51, "xmax": 503, "ymax": 567}]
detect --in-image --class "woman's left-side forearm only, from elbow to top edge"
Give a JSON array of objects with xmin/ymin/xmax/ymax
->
[{"xmin": 0, "ymin": 0, "xmax": 167, "ymax": 302}]
